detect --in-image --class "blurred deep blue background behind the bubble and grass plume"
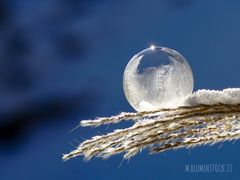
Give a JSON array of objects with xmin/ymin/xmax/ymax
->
[{"xmin": 0, "ymin": 0, "xmax": 240, "ymax": 180}]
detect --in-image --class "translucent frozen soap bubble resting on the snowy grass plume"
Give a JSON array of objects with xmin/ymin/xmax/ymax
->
[{"xmin": 123, "ymin": 46, "xmax": 193, "ymax": 111}]
